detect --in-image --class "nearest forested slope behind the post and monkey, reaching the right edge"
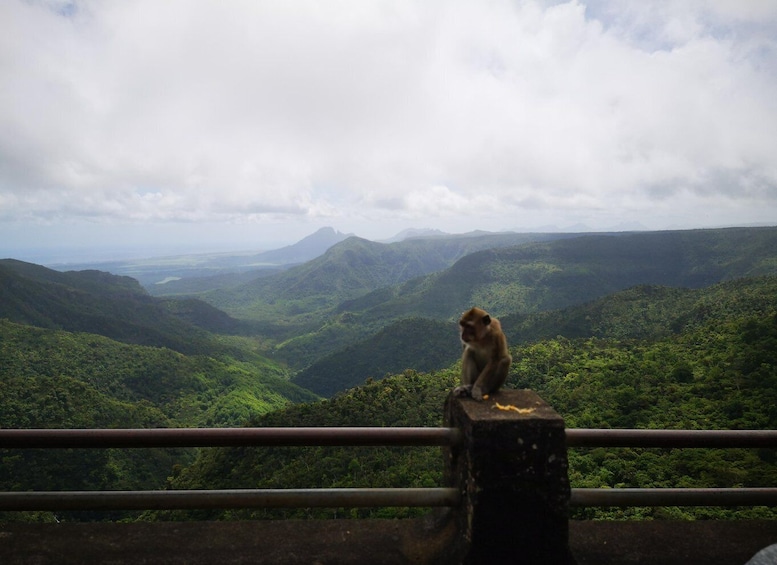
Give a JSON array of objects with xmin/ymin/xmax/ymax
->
[{"xmin": 157, "ymin": 293, "xmax": 777, "ymax": 518}]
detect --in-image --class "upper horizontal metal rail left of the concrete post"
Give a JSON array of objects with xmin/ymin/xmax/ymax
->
[{"xmin": 0, "ymin": 427, "xmax": 461, "ymax": 449}]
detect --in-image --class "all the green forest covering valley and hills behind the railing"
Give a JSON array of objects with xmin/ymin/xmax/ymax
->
[{"xmin": 0, "ymin": 229, "xmax": 777, "ymax": 521}]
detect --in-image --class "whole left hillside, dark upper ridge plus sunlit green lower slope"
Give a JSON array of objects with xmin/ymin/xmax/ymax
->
[{"xmin": 0, "ymin": 260, "xmax": 317, "ymax": 508}]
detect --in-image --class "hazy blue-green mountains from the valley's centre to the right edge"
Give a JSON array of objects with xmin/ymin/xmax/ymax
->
[{"xmin": 180, "ymin": 228, "xmax": 777, "ymax": 382}]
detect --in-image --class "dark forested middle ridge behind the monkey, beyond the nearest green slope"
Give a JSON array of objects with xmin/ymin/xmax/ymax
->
[{"xmin": 284, "ymin": 276, "xmax": 777, "ymax": 396}]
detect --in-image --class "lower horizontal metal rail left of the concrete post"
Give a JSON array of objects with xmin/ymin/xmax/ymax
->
[{"xmin": 0, "ymin": 488, "xmax": 460, "ymax": 511}]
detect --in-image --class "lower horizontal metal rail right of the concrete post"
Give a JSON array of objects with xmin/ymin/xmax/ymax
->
[{"xmin": 569, "ymin": 488, "xmax": 777, "ymax": 507}]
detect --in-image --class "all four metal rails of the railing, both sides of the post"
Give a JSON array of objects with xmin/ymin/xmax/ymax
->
[{"xmin": 0, "ymin": 427, "xmax": 777, "ymax": 510}]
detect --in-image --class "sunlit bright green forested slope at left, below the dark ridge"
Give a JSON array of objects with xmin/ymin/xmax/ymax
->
[{"xmin": 0, "ymin": 320, "xmax": 316, "ymax": 518}]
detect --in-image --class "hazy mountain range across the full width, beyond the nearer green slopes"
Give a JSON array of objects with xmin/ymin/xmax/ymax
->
[{"xmin": 7, "ymin": 223, "xmax": 777, "ymax": 394}]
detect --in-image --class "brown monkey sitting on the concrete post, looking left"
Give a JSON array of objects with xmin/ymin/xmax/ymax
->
[{"xmin": 453, "ymin": 308, "xmax": 513, "ymax": 400}]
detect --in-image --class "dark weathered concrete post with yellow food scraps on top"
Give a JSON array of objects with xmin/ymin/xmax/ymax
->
[{"xmin": 445, "ymin": 390, "xmax": 574, "ymax": 565}]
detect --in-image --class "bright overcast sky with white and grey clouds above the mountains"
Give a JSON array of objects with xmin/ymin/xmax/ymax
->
[{"xmin": 0, "ymin": 0, "xmax": 777, "ymax": 260}]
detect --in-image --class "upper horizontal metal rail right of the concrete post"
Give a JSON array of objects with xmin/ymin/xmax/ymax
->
[{"xmin": 566, "ymin": 428, "xmax": 777, "ymax": 448}]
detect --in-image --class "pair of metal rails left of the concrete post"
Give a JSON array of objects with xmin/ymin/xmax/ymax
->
[{"xmin": 0, "ymin": 427, "xmax": 461, "ymax": 511}]
